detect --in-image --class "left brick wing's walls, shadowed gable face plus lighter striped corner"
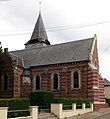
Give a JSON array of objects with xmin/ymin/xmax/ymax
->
[{"xmin": 0, "ymin": 51, "xmax": 23, "ymax": 98}]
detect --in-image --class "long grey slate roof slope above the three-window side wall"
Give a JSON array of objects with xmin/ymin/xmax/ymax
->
[{"xmin": 10, "ymin": 38, "xmax": 94, "ymax": 68}]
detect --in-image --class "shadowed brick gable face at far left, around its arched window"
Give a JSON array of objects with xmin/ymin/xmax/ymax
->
[{"xmin": 0, "ymin": 52, "xmax": 14, "ymax": 98}]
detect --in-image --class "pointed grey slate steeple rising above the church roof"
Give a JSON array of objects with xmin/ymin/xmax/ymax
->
[{"xmin": 25, "ymin": 12, "xmax": 50, "ymax": 48}]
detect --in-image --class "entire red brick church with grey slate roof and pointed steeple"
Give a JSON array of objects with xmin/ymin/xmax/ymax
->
[{"xmin": 0, "ymin": 14, "xmax": 105, "ymax": 108}]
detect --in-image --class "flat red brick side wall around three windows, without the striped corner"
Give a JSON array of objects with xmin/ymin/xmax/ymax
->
[{"xmin": 31, "ymin": 62, "xmax": 88, "ymax": 98}]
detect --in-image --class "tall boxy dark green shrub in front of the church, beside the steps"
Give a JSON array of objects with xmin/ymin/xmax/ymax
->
[{"xmin": 30, "ymin": 91, "xmax": 53, "ymax": 107}]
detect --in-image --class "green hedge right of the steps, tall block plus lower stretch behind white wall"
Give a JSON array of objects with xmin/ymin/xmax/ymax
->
[{"xmin": 30, "ymin": 91, "xmax": 90, "ymax": 109}]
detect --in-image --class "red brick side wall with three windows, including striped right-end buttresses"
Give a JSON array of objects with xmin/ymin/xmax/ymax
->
[{"xmin": 31, "ymin": 62, "xmax": 106, "ymax": 109}]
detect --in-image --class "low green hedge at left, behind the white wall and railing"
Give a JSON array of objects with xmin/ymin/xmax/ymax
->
[{"xmin": 0, "ymin": 98, "xmax": 29, "ymax": 118}]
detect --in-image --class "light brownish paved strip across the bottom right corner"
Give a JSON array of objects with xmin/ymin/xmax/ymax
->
[{"xmin": 67, "ymin": 108, "xmax": 110, "ymax": 119}]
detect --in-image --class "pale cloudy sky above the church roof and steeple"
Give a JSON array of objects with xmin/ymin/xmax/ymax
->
[{"xmin": 0, "ymin": 0, "xmax": 110, "ymax": 81}]
